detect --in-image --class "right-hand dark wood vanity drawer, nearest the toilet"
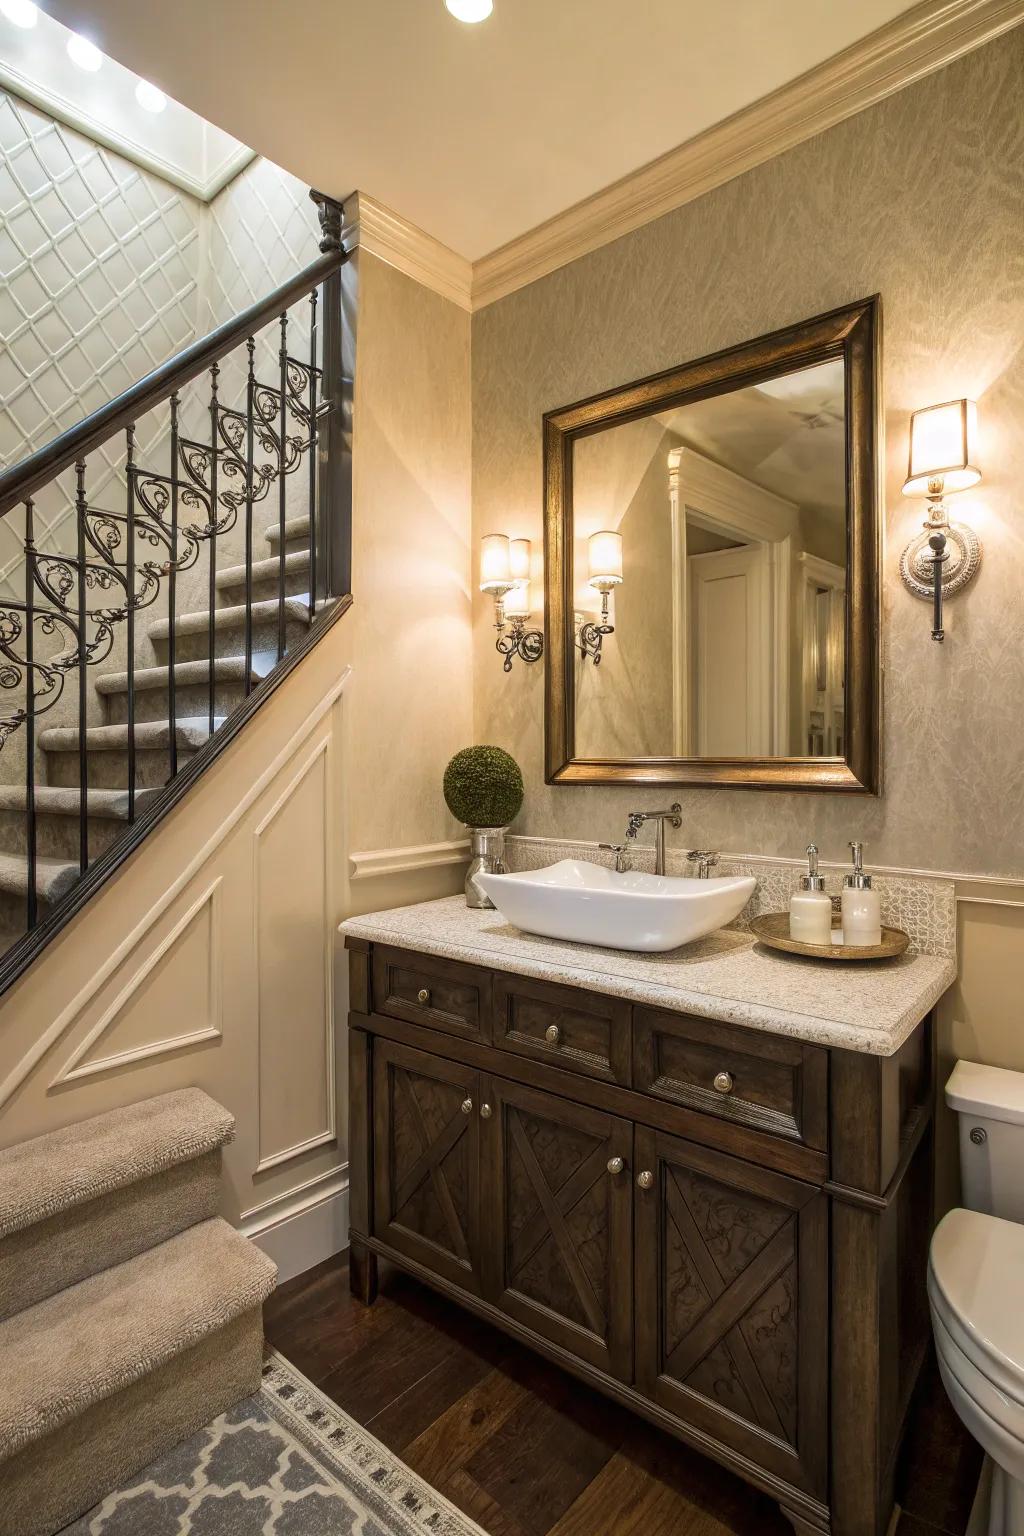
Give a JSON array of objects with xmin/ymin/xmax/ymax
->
[{"xmin": 633, "ymin": 1008, "xmax": 827, "ymax": 1150}]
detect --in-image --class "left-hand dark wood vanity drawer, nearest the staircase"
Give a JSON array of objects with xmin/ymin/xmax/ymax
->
[{"xmin": 373, "ymin": 945, "xmax": 491, "ymax": 1044}]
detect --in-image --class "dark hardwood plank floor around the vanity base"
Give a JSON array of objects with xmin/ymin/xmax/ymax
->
[{"xmin": 264, "ymin": 1256, "xmax": 981, "ymax": 1536}]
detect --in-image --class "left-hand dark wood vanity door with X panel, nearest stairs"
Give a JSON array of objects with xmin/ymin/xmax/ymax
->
[{"xmin": 373, "ymin": 1040, "xmax": 482, "ymax": 1295}]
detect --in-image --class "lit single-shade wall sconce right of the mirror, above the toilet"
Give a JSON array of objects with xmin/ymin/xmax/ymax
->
[{"xmin": 900, "ymin": 399, "xmax": 981, "ymax": 641}]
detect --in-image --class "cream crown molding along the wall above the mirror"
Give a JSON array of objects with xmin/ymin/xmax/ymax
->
[{"xmin": 471, "ymin": 0, "xmax": 1024, "ymax": 310}]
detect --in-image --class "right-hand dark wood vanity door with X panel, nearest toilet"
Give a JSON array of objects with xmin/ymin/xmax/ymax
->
[{"xmin": 634, "ymin": 1127, "xmax": 829, "ymax": 1496}]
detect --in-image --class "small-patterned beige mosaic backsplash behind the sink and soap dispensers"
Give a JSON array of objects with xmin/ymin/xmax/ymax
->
[{"xmin": 505, "ymin": 836, "xmax": 956, "ymax": 960}]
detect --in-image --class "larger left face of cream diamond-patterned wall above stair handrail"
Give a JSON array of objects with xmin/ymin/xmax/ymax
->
[{"xmin": 0, "ymin": 92, "xmax": 203, "ymax": 581}]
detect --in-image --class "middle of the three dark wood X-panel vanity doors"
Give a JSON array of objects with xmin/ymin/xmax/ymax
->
[{"xmin": 484, "ymin": 1078, "xmax": 633, "ymax": 1381}]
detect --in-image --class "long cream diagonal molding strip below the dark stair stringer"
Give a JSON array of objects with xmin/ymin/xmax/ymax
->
[{"xmin": 0, "ymin": 666, "xmax": 352, "ymax": 1109}]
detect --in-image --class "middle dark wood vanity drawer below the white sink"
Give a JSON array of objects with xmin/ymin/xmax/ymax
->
[{"xmin": 494, "ymin": 974, "xmax": 631, "ymax": 1087}]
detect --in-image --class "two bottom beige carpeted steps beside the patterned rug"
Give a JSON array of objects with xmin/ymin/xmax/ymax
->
[{"xmin": 0, "ymin": 1089, "xmax": 276, "ymax": 1536}]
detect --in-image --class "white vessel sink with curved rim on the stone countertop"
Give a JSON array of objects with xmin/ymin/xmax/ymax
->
[{"xmin": 476, "ymin": 859, "xmax": 757, "ymax": 951}]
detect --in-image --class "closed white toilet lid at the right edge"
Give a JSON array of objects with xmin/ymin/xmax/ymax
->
[{"xmin": 929, "ymin": 1210, "xmax": 1024, "ymax": 1399}]
